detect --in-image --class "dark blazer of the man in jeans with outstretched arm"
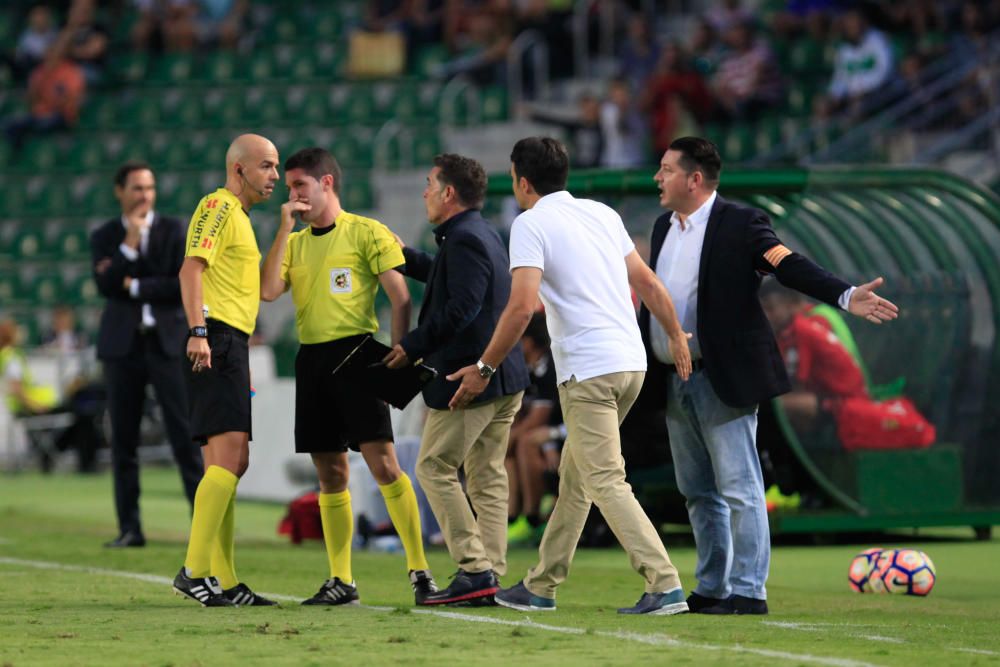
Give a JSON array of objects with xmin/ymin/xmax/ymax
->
[{"xmin": 639, "ymin": 197, "xmax": 850, "ymax": 407}]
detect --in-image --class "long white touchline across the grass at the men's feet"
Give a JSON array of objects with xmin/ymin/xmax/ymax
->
[{"xmin": 0, "ymin": 557, "xmax": 875, "ymax": 667}]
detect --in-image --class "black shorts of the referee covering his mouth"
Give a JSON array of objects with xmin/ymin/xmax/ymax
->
[{"xmin": 295, "ymin": 336, "xmax": 392, "ymax": 454}]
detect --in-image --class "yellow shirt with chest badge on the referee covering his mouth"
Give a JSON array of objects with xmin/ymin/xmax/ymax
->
[{"xmin": 281, "ymin": 211, "xmax": 405, "ymax": 345}]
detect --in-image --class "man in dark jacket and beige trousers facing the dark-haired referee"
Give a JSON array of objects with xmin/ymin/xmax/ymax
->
[{"xmin": 386, "ymin": 154, "xmax": 528, "ymax": 605}]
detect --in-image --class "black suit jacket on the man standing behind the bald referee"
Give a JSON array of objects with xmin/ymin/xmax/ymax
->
[{"xmin": 90, "ymin": 214, "xmax": 187, "ymax": 359}]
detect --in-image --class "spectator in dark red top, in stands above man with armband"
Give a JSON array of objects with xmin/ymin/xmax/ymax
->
[{"xmin": 641, "ymin": 44, "xmax": 712, "ymax": 155}]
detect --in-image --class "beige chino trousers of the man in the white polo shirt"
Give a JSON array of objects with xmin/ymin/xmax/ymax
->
[{"xmin": 524, "ymin": 372, "xmax": 681, "ymax": 598}]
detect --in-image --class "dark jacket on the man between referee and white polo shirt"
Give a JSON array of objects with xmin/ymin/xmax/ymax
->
[{"xmin": 400, "ymin": 210, "xmax": 528, "ymax": 410}]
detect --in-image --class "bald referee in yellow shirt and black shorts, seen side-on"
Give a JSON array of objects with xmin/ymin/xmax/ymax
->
[{"xmin": 174, "ymin": 134, "xmax": 278, "ymax": 607}]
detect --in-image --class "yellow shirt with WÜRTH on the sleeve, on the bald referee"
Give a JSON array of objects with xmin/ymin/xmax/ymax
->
[{"xmin": 185, "ymin": 188, "xmax": 260, "ymax": 334}]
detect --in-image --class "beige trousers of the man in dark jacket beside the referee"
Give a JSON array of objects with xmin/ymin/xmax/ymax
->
[{"xmin": 417, "ymin": 391, "xmax": 524, "ymax": 576}]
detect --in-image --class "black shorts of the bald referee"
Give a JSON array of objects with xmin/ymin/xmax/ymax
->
[{"xmin": 184, "ymin": 319, "xmax": 253, "ymax": 445}]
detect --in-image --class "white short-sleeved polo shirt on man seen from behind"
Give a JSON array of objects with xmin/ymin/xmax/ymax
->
[{"xmin": 510, "ymin": 191, "xmax": 646, "ymax": 384}]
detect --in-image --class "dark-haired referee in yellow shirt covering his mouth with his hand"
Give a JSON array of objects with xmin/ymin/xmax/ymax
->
[{"xmin": 260, "ymin": 148, "xmax": 437, "ymax": 605}]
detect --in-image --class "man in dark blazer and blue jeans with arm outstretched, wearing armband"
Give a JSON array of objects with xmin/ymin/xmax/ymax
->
[{"xmin": 639, "ymin": 137, "xmax": 898, "ymax": 614}]
